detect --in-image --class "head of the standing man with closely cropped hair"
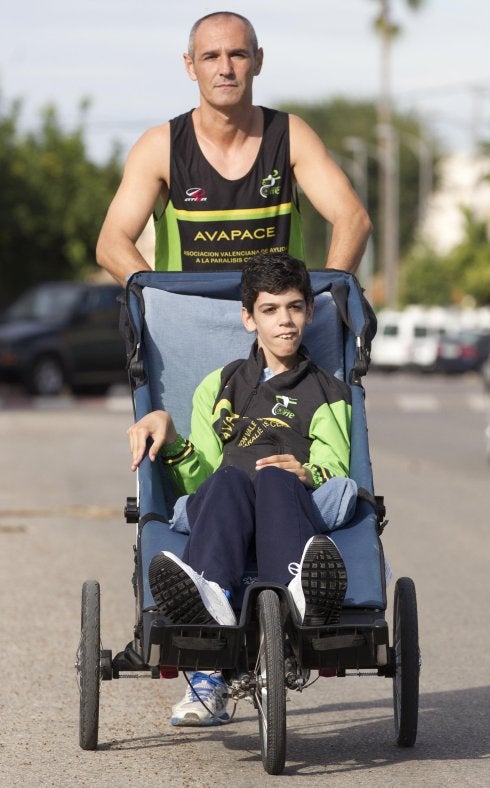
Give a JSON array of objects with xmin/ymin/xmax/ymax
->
[{"xmin": 184, "ymin": 17, "xmax": 262, "ymax": 108}]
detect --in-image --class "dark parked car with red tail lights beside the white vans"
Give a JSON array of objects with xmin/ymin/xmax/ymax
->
[{"xmin": 436, "ymin": 331, "xmax": 490, "ymax": 373}]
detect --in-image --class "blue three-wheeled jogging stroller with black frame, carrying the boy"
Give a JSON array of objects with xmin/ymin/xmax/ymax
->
[{"xmin": 76, "ymin": 270, "xmax": 419, "ymax": 774}]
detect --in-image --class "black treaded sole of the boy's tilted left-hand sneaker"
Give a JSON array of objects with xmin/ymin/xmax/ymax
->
[{"xmin": 148, "ymin": 553, "xmax": 217, "ymax": 624}]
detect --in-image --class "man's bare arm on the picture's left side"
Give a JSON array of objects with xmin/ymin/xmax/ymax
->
[{"xmin": 96, "ymin": 123, "xmax": 170, "ymax": 286}]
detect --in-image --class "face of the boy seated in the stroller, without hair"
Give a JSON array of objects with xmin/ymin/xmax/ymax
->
[{"xmin": 242, "ymin": 289, "xmax": 313, "ymax": 372}]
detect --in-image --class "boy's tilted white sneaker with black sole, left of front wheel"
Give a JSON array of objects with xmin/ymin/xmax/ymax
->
[{"xmin": 148, "ymin": 552, "xmax": 236, "ymax": 626}]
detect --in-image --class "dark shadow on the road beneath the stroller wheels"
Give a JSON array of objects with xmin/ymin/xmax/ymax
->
[{"xmin": 99, "ymin": 686, "xmax": 490, "ymax": 775}]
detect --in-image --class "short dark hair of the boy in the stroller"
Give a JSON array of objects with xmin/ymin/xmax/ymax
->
[{"xmin": 241, "ymin": 254, "xmax": 313, "ymax": 314}]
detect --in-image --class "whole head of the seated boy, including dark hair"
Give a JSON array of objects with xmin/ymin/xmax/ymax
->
[{"xmin": 242, "ymin": 254, "xmax": 313, "ymax": 372}]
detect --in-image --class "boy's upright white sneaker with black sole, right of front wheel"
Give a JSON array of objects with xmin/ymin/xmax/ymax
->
[{"xmin": 288, "ymin": 534, "xmax": 347, "ymax": 627}]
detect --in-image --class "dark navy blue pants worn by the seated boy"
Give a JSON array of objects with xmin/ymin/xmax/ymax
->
[{"xmin": 183, "ymin": 466, "xmax": 320, "ymax": 590}]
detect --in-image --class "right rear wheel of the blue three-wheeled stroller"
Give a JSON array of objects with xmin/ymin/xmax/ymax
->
[{"xmin": 393, "ymin": 577, "xmax": 420, "ymax": 747}]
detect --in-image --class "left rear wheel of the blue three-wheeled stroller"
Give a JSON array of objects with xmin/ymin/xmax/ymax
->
[{"xmin": 77, "ymin": 580, "xmax": 100, "ymax": 750}]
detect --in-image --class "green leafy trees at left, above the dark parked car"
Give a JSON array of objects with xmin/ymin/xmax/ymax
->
[{"xmin": 0, "ymin": 95, "xmax": 121, "ymax": 305}]
